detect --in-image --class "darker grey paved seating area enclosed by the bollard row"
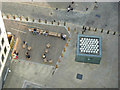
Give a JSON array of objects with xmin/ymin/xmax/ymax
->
[{"xmin": 5, "ymin": 21, "xmax": 69, "ymax": 66}]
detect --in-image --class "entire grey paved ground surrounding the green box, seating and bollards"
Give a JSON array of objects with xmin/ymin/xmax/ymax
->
[{"xmin": 2, "ymin": 2, "xmax": 118, "ymax": 88}]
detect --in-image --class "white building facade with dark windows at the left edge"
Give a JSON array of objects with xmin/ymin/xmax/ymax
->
[{"xmin": 0, "ymin": 11, "xmax": 10, "ymax": 89}]
